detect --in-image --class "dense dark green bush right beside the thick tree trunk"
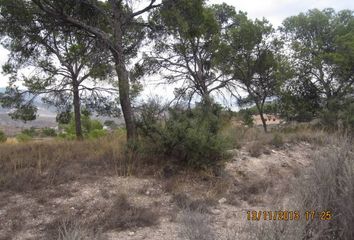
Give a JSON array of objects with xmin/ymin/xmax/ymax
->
[{"xmin": 139, "ymin": 103, "xmax": 231, "ymax": 169}]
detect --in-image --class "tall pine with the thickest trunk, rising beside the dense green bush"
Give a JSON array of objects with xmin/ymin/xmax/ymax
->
[{"xmin": 27, "ymin": 0, "xmax": 159, "ymax": 140}]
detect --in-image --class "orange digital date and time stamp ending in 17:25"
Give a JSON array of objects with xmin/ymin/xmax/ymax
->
[{"xmin": 247, "ymin": 210, "xmax": 333, "ymax": 221}]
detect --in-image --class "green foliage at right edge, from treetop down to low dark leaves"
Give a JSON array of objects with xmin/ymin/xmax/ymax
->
[{"xmin": 281, "ymin": 9, "xmax": 354, "ymax": 126}]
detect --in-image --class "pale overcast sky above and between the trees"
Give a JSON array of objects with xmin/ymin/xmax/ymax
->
[{"xmin": 0, "ymin": 0, "xmax": 354, "ymax": 105}]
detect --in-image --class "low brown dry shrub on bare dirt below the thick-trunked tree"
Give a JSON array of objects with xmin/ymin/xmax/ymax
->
[{"xmin": 101, "ymin": 194, "xmax": 159, "ymax": 230}]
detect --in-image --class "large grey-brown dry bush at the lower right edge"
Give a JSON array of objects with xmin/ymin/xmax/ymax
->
[{"xmin": 296, "ymin": 137, "xmax": 354, "ymax": 240}]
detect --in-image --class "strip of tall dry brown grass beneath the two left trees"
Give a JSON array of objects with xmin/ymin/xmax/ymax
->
[{"xmin": 0, "ymin": 131, "xmax": 135, "ymax": 191}]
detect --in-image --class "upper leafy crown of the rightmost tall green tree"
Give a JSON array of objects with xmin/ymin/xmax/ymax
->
[{"xmin": 281, "ymin": 9, "xmax": 354, "ymax": 118}]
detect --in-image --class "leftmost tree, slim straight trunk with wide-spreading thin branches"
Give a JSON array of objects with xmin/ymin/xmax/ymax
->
[{"xmin": 0, "ymin": 1, "xmax": 117, "ymax": 139}]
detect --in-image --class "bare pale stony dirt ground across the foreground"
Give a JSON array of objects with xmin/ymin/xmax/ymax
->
[{"xmin": 0, "ymin": 143, "xmax": 312, "ymax": 240}]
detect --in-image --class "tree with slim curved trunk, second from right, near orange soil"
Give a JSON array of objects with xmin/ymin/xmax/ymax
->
[{"xmin": 223, "ymin": 16, "xmax": 285, "ymax": 131}]
